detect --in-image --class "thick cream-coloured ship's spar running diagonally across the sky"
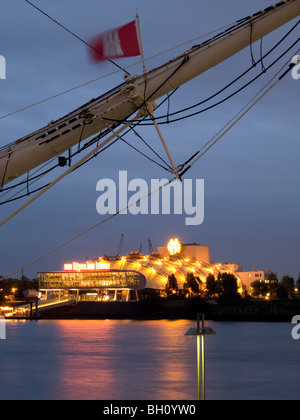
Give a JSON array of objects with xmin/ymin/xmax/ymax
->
[{"xmin": 0, "ymin": 0, "xmax": 300, "ymax": 187}]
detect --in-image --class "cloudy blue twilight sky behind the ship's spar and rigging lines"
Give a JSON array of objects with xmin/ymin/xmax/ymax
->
[{"xmin": 0, "ymin": 0, "xmax": 300, "ymax": 277}]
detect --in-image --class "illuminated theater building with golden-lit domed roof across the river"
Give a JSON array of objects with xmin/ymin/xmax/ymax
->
[{"xmin": 38, "ymin": 239, "xmax": 238, "ymax": 301}]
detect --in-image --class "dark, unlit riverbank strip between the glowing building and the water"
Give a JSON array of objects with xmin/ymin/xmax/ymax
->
[{"xmin": 39, "ymin": 299, "xmax": 300, "ymax": 322}]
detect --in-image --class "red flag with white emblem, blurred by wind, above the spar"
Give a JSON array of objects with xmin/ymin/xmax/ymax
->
[{"xmin": 90, "ymin": 21, "xmax": 141, "ymax": 61}]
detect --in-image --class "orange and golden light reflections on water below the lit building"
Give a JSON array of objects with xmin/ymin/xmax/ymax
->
[{"xmin": 57, "ymin": 320, "xmax": 197, "ymax": 400}]
